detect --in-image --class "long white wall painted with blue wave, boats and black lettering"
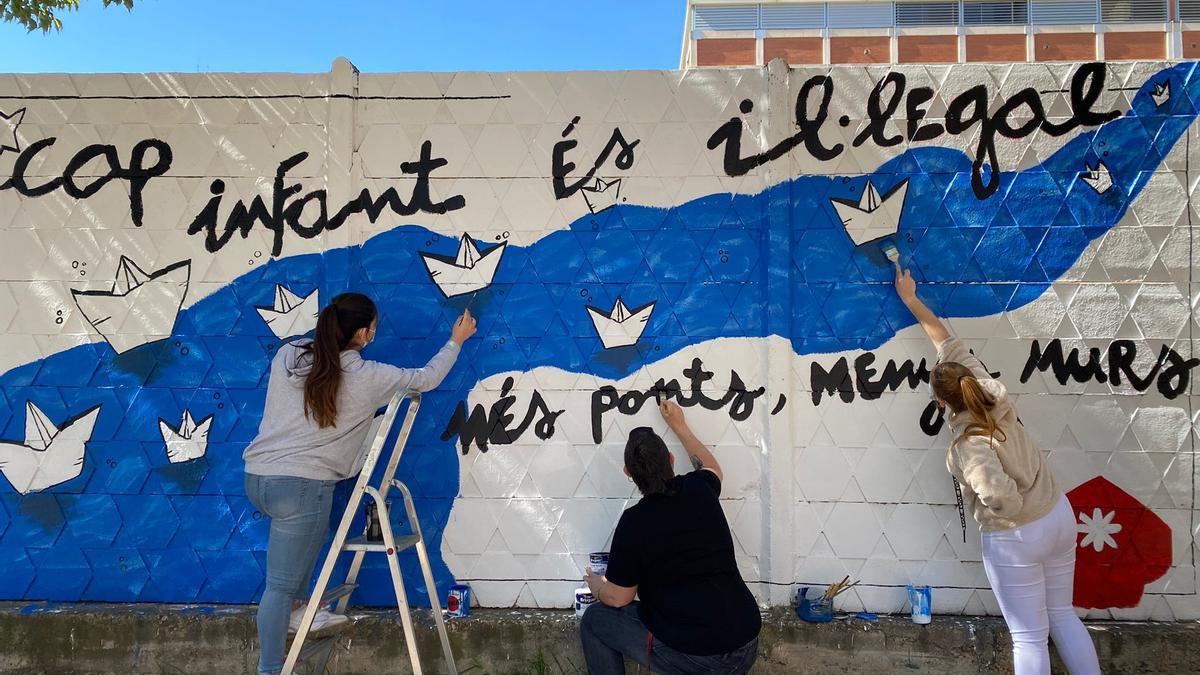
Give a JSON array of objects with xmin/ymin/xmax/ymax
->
[{"xmin": 0, "ymin": 61, "xmax": 1200, "ymax": 619}]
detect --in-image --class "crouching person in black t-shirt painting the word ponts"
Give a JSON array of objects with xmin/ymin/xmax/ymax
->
[{"xmin": 580, "ymin": 401, "xmax": 762, "ymax": 675}]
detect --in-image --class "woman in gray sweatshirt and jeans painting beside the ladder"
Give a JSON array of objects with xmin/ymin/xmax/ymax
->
[{"xmin": 242, "ymin": 293, "xmax": 475, "ymax": 674}]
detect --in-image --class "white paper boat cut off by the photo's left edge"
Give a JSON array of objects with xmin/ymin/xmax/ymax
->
[{"xmin": 0, "ymin": 401, "xmax": 100, "ymax": 495}]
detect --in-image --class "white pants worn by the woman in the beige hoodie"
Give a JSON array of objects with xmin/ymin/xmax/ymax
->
[{"xmin": 983, "ymin": 496, "xmax": 1100, "ymax": 675}]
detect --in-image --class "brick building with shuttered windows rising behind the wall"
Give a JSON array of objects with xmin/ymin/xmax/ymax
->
[{"xmin": 679, "ymin": 0, "xmax": 1200, "ymax": 67}]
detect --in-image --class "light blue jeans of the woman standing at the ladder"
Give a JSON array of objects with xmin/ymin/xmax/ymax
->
[{"xmin": 246, "ymin": 473, "xmax": 337, "ymax": 675}]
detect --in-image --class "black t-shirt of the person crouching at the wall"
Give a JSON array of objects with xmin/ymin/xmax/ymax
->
[{"xmin": 606, "ymin": 470, "xmax": 762, "ymax": 656}]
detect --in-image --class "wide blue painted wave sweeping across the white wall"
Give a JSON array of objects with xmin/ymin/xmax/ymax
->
[{"xmin": 0, "ymin": 64, "xmax": 1200, "ymax": 604}]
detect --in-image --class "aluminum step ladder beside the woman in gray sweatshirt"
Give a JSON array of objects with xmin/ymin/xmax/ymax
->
[{"xmin": 283, "ymin": 392, "xmax": 458, "ymax": 675}]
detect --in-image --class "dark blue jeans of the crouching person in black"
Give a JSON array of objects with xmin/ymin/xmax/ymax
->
[{"xmin": 580, "ymin": 603, "xmax": 758, "ymax": 675}]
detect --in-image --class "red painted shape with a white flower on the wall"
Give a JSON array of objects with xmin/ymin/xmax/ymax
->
[{"xmin": 1067, "ymin": 476, "xmax": 1171, "ymax": 609}]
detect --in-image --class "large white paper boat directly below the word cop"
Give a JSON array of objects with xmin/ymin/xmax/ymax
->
[{"xmin": 71, "ymin": 256, "xmax": 192, "ymax": 354}]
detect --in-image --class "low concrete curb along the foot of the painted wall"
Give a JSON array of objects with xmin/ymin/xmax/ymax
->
[{"xmin": 0, "ymin": 603, "xmax": 1200, "ymax": 675}]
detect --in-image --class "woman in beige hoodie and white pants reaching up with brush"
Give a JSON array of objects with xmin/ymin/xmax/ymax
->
[{"xmin": 896, "ymin": 264, "xmax": 1100, "ymax": 675}]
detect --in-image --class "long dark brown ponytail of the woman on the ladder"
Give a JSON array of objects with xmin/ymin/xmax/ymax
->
[{"xmin": 302, "ymin": 293, "xmax": 376, "ymax": 429}]
